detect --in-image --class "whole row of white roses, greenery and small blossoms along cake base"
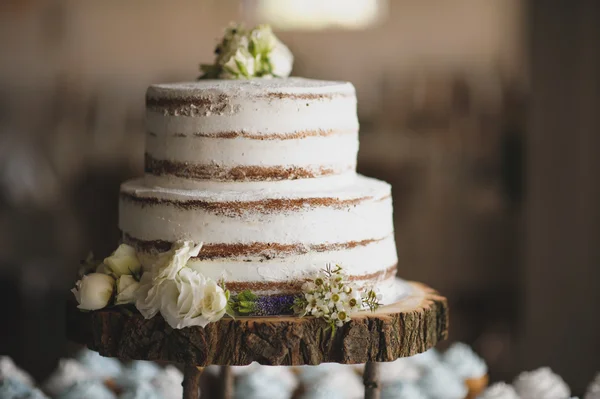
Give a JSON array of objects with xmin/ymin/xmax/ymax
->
[{"xmin": 72, "ymin": 241, "xmax": 382, "ymax": 335}]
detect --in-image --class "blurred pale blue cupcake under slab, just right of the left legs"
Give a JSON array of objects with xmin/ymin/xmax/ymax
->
[{"xmin": 234, "ymin": 365, "xmax": 298, "ymax": 399}]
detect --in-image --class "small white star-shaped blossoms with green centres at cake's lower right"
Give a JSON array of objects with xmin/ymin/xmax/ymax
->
[{"xmin": 295, "ymin": 265, "xmax": 381, "ymax": 328}]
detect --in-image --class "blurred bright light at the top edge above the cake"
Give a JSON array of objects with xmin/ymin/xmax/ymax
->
[{"xmin": 248, "ymin": 0, "xmax": 388, "ymax": 30}]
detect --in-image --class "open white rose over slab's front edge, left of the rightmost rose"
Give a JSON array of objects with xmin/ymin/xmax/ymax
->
[{"xmin": 160, "ymin": 267, "xmax": 210, "ymax": 328}]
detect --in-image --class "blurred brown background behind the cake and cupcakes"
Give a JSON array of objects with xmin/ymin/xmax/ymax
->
[{"xmin": 0, "ymin": 0, "xmax": 600, "ymax": 394}]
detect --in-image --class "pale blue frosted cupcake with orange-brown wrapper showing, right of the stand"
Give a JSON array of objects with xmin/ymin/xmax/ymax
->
[{"xmin": 442, "ymin": 342, "xmax": 489, "ymax": 399}]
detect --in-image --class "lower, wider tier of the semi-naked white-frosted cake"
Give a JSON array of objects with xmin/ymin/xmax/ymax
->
[{"xmin": 119, "ymin": 175, "xmax": 397, "ymax": 293}]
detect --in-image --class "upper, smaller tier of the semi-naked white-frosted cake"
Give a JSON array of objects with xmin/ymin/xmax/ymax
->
[{"xmin": 146, "ymin": 78, "xmax": 358, "ymax": 181}]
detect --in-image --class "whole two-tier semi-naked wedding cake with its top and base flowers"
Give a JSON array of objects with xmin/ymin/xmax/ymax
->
[{"xmin": 72, "ymin": 21, "xmax": 407, "ymax": 331}]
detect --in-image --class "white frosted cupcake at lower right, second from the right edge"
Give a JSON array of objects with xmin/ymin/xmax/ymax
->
[{"xmin": 513, "ymin": 367, "xmax": 571, "ymax": 399}]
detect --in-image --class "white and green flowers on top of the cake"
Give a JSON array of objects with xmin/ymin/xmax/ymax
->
[{"xmin": 200, "ymin": 25, "xmax": 294, "ymax": 79}]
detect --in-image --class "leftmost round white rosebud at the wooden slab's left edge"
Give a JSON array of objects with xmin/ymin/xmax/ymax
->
[{"xmin": 71, "ymin": 273, "xmax": 115, "ymax": 310}]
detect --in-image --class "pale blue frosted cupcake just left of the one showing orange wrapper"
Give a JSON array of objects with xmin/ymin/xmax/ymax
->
[{"xmin": 418, "ymin": 364, "xmax": 469, "ymax": 399}]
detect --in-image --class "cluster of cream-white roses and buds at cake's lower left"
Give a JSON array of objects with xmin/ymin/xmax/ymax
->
[{"xmin": 72, "ymin": 241, "xmax": 229, "ymax": 328}]
